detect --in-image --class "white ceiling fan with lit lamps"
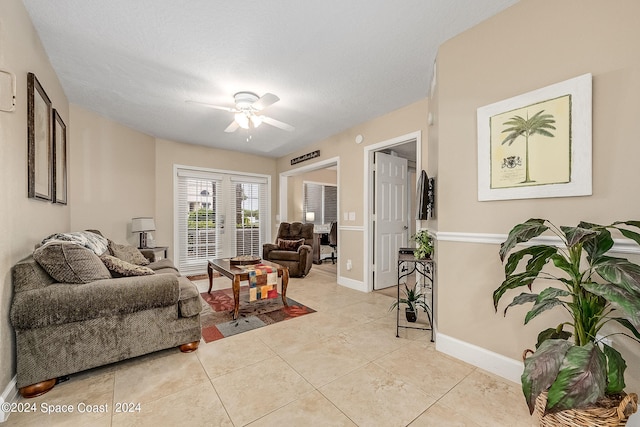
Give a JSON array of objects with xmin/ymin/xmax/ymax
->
[{"xmin": 187, "ymin": 92, "xmax": 295, "ymax": 133}]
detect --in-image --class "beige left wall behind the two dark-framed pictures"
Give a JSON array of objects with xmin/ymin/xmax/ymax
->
[{"xmin": 0, "ymin": 0, "xmax": 73, "ymax": 393}]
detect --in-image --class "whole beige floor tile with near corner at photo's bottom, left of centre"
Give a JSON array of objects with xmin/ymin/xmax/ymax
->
[{"xmin": 212, "ymin": 356, "xmax": 313, "ymax": 426}]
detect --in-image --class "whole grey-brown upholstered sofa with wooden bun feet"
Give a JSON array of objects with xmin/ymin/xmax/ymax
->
[{"xmin": 10, "ymin": 232, "xmax": 202, "ymax": 397}]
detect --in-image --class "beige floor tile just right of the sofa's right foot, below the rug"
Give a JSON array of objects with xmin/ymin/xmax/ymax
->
[{"xmin": 196, "ymin": 333, "xmax": 275, "ymax": 378}]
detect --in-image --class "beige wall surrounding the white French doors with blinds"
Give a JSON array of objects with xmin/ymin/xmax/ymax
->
[{"xmin": 155, "ymin": 139, "xmax": 277, "ymax": 256}]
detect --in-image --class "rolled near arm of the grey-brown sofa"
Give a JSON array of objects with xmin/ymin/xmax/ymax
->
[{"xmin": 11, "ymin": 272, "xmax": 180, "ymax": 330}]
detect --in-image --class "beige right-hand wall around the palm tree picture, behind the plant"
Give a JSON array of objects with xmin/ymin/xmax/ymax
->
[{"xmin": 436, "ymin": 0, "xmax": 640, "ymax": 391}]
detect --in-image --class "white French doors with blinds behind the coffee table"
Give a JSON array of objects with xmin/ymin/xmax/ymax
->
[{"xmin": 175, "ymin": 169, "xmax": 270, "ymax": 274}]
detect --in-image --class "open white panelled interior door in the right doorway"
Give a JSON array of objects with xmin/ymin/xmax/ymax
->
[{"xmin": 373, "ymin": 152, "xmax": 407, "ymax": 289}]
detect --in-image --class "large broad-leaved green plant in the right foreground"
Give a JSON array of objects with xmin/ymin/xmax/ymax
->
[{"xmin": 493, "ymin": 219, "xmax": 640, "ymax": 425}]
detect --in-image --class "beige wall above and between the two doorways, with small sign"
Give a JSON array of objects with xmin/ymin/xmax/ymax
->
[{"xmin": 274, "ymin": 99, "xmax": 428, "ymax": 283}]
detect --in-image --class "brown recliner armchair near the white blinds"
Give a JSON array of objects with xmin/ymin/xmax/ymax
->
[{"xmin": 262, "ymin": 222, "xmax": 313, "ymax": 277}]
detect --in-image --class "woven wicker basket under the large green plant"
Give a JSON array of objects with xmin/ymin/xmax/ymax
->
[{"xmin": 535, "ymin": 392, "xmax": 638, "ymax": 427}]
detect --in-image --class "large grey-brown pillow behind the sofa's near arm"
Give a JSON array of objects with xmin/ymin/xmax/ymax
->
[{"xmin": 33, "ymin": 241, "xmax": 111, "ymax": 283}]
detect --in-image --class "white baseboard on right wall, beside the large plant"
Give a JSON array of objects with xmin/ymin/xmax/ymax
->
[{"xmin": 436, "ymin": 333, "xmax": 524, "ymax": 384}]
